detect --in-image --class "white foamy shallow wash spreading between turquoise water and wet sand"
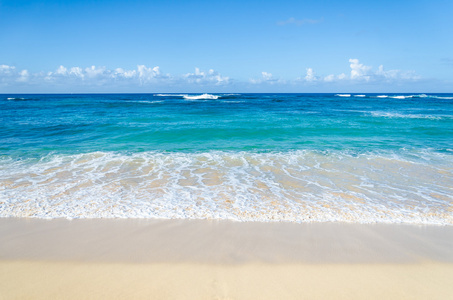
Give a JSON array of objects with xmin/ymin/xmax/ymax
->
[{"xmin": 0, "ymin": 151, "xmax": 453, "ymax": 224}]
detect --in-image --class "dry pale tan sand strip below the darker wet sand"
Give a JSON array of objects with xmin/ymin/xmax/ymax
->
[{"xmin": 0, "ymin": 261, "xmax": 453, "ymax": 299}]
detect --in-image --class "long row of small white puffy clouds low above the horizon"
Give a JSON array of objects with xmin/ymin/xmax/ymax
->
[{"xmin": 0, "ymin": 58, "xmax": 421, "ymax": 91}]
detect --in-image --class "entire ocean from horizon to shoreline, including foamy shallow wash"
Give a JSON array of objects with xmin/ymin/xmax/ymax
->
[{"xmin": 0, "ymin": 94, "xmax": 453, "ymax": 225}]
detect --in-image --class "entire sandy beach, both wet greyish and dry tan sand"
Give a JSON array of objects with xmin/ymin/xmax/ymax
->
[{"xmin": 0, "ymin": 218, "xmax": 453, "ymax": 299}]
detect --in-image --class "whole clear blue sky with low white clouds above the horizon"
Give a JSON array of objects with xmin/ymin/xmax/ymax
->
[{"xmin": 0, "ymin": 0, "xmax": 453, "ymax": 93}]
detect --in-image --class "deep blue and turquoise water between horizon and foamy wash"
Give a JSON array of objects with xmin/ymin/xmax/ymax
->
[{"xmin": 0, "ymin": 94, "xmax": 453, "ymax": 155}]
